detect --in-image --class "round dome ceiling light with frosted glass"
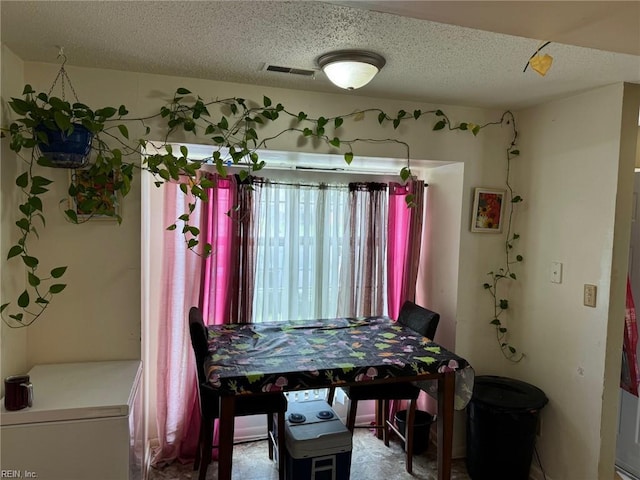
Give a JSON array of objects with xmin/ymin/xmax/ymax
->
[{"xmin": 318, "ymin": 50, "xmax": 386, "ymax": 90}]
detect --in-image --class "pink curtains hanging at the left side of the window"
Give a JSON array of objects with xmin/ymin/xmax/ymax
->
[{"xmin": 153, "ymin": 175, "xmax": 253, "ymax": 464}]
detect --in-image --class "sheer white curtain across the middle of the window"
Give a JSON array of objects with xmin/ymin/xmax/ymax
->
[{"xmin": 253, "ymin": 181, "xmax": 349, "ymax": 323}]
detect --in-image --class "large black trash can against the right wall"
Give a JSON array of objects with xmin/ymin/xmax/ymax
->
[{"xmin": 467, "ymin": 375, "xmax": 548, "ymax": 480}]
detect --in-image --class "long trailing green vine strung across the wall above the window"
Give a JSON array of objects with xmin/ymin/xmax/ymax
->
[{"xmin": 0, "ymin": 85, "xmax": 522, "ymax": 361}]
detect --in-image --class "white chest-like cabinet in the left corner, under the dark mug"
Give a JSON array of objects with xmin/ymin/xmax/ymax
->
[{"xmin": 0, "ymin": 360, "xmax": 144, "ymax": 480}]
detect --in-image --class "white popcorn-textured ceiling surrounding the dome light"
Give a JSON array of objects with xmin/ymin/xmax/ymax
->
[{"xmin": 0, "ymin": 0, "xmax": 640, "ymax": 109}]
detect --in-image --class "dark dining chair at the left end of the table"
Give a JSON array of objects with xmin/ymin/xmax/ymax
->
[{"xmin": 189, "ymin": 307, "xmax": 287, "ymax": 480}]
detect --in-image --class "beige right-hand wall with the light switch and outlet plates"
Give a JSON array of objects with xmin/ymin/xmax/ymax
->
[{"xmin": 507, "ymin": 85, "xmax": 638, "ymax": 480}]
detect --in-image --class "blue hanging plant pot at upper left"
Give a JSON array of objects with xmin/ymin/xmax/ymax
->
[{"xmin": 36, "ymin": 123, "xmax": 93, "ymax": 168}]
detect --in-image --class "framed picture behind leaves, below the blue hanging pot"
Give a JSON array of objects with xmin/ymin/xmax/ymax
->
[{"xmin": 69, "ymin": 170, "xmax": 122, "ymax": 221}]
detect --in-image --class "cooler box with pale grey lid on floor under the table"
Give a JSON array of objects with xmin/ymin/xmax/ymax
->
[{"xmin": 285, "ymin": 400, "xmax": 352, "ymax": 480}]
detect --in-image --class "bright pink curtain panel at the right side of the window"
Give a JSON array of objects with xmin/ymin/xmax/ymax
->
[{"xmin": 387, "ymin": 180, "xmax": 424, "ymax": 319}]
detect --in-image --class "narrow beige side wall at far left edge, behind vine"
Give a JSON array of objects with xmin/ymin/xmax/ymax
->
[{"xmin": 0, "ymin": 44, "xmax": 28, "ymax": 395}]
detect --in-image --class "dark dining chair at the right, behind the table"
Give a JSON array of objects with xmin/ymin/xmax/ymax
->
[{"xmin": 327, "ymin": 300, "xmax": 440, "ymax": 473}]
